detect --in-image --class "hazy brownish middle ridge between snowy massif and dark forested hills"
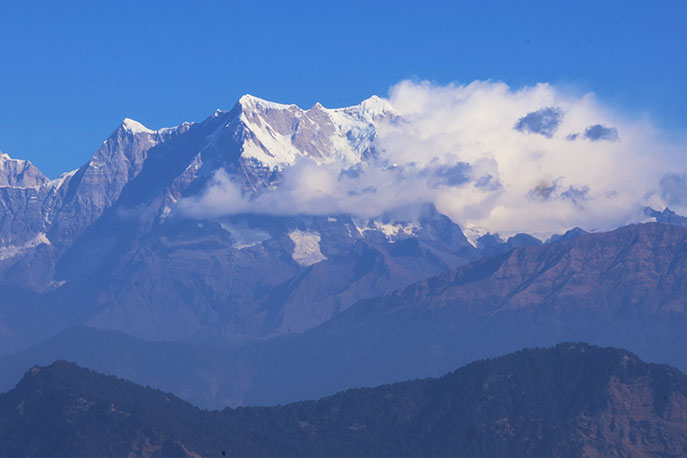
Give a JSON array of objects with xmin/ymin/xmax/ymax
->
[{"xmin": 0, "ymin": 223, "xmax": 687, "ymax": 407}]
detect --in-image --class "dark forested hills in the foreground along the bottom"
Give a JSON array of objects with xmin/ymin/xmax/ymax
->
[{"xmin": 0, "ymin": 343, "xmax": 687, "ymax": 457}]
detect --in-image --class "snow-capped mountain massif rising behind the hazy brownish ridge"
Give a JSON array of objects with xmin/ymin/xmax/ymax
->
[{"xmin": 0, "ymin": 96, "xmax": 505, "ymax": 353}]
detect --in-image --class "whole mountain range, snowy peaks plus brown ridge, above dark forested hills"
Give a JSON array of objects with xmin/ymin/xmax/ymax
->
[{"xmin": 0, "ymin": 92, "xmax": 687, "ymax": 416}]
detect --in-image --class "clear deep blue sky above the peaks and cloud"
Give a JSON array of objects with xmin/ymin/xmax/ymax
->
[{"xmin": 0, "ymin": 0, "xmax": 687, "ymax": 177}]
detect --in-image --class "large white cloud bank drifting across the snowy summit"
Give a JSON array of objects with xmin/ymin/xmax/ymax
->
[{"xmin": 181, "ymin": 81, "xmax": 687, "ymax": 237}]
